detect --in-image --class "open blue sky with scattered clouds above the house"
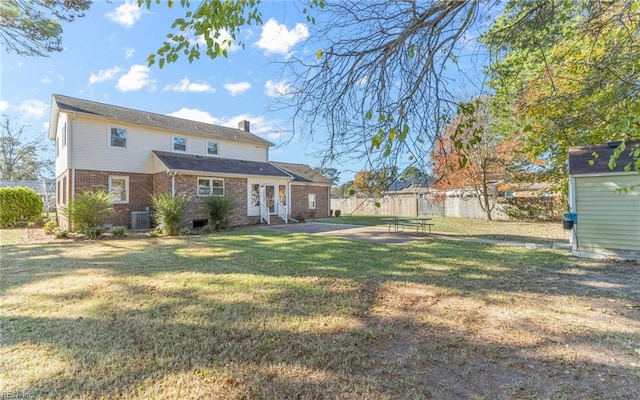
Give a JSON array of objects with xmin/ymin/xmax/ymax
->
[{"xmin": 0, "ymin": 0, "xmax": 360, "ymax": 182}]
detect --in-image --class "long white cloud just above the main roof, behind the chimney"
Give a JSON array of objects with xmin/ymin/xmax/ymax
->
[{"xmin": 167, "ymin": 108, "xmax": 286, "ymax": 140}]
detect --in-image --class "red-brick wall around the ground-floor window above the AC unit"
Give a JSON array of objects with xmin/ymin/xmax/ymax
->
[{"xmin": 75, "ymin": 170, "xmax": 153, "ymax": 228}]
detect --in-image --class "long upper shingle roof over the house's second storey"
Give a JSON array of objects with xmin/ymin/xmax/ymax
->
[{"xmin": 53, "ymin": 94, "xmax": 273, "ymax": 146}]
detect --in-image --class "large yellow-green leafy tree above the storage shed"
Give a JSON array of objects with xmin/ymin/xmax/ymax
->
[{"xmin": 483, "ymin": 0, "xmax": 640, "ymax": 186}]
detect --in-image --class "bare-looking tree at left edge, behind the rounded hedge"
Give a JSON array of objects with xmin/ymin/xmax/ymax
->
[{"xmin": 0, "ymin": 115, "xmax": 53, "ymax": 181}]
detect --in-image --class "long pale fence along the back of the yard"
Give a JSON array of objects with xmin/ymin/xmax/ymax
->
[{"xmin": 331, "ymin": 197, "xmax": 509, "ymax": 220}]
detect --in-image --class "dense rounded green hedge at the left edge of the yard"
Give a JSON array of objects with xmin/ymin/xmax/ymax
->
[{"xmin": 0, "ymin": 187, "xmax": 44, "ymax": 227}]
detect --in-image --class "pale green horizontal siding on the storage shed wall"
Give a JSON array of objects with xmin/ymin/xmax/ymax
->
[{"xmin": 573, "ymin": 173, "xmax": 640, "ymax": 257}]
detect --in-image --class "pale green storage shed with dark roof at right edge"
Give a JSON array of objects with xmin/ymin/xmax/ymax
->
[{"xmin": 565, "ymin": 142, "xmax": 640, "ymax": 259}]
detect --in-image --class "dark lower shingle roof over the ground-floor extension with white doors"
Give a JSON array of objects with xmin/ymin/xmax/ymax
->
[{"xmin": 153, "ymin": 150, "xmax": 291, "ymax": 178}]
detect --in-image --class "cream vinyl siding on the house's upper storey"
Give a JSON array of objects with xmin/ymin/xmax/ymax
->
[{"xmin": 69, "ymin": 114, "xmax": 268, "ymax": 175}]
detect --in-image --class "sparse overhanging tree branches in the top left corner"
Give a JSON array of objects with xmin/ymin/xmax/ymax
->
[{"xmin": 0, "ymin": 0, "xmax": 91, "ymax": 57}]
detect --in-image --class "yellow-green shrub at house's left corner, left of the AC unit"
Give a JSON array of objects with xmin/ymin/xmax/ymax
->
[{"xmin": 62, "ymin": 190, "xmax": 113, "ymax": 231}]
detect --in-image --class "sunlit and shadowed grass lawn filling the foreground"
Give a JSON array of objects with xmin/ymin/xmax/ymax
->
[{"xmin": 0, "ymin": 228, "xmax": 640, "ymax": 399}]
